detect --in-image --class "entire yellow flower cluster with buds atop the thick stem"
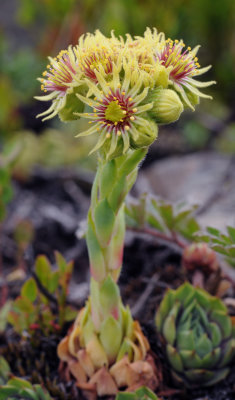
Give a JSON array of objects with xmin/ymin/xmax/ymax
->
[{"xmin": 37, "ymin": 28, "xmax": 214, "ymax": 158}]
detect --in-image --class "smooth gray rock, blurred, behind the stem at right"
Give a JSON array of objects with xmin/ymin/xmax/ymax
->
[{"xmin": 135, "ymin": 152, "xmax": 235, "ymax": 229}]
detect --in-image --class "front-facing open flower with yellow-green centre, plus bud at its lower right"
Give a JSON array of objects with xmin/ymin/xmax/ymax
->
[{"xmin": 74, "ymin": 66, "xmax": 157, "ymax": 158}]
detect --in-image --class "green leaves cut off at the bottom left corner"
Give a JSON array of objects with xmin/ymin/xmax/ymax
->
[{"xmin": 0, "ymin": 377, "xmax": 53, "ymax": 400}]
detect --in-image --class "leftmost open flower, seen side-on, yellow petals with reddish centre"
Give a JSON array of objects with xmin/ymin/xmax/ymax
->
[{"xmin": 35, "ymin": 46, "xmax": 81, "ymax": 121}]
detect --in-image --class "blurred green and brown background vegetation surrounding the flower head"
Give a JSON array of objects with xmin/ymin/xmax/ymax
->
[{"xmin": 0, "ymin": 0, "xmax": 235, "ymax": 176}]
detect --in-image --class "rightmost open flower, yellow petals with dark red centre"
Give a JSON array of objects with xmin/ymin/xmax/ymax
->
[{"xmin": 155, "ymin": 39, "xmax": 215, "ymax": 109}]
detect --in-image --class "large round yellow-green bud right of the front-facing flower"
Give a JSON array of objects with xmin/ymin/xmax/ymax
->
[{"xmin": 148, "ymin": 89, "xmax": 184, "ymax": 124}]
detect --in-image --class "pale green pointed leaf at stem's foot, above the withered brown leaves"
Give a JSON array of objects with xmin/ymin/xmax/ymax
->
[{"xmin": 99, "ymin": 315, "xmax": 122, "ymax": 363}]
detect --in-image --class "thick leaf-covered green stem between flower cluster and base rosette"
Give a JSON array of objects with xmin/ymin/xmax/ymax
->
[{"xmin": 86, "ymin": 149, "xmax": 147, "ymax": 329}]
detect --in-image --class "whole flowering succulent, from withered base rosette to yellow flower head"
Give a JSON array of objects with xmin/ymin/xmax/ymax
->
[{"xmin": 35, "ymin": 29, "xmax": 214, "ymax": 396}]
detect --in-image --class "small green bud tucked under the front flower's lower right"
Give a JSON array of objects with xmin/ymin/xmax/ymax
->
[{"xmin": 130, "ymin": 119, "xmax": 158, "ymax": 149}]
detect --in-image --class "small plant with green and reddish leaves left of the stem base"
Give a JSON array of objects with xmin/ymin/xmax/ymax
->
[{"xmin": 8, "ymin": 252, "xmax": 76, "ymax": 335}]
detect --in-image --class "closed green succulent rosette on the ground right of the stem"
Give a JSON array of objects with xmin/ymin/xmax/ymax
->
[{"xmin": 156, "ymin": 283, "xmax": 235, "ymax": 387}]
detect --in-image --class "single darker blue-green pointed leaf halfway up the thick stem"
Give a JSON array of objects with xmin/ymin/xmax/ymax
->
[{"xmin": 94, "ymin": 199, "xmax": 115, "ymax": 247}]
